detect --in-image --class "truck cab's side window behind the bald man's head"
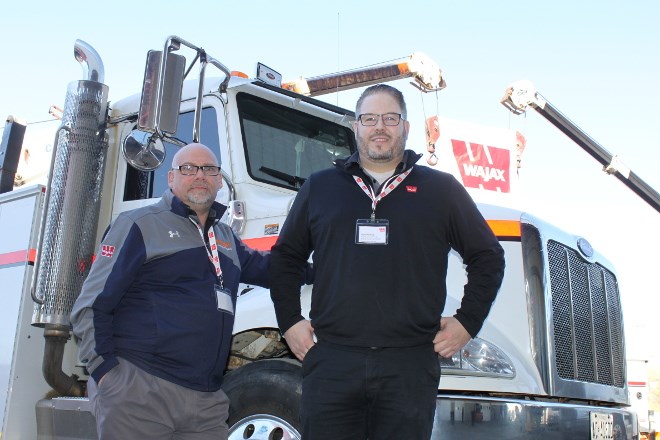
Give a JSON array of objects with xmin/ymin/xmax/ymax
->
[{"xmin": 124, "ymin": 107, "xmax": 220, "ymax": 201}]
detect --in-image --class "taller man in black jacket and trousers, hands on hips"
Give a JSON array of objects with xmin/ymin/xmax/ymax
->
[{"xmin": 271, "ymin": 84, "xmax": 504, "ymax": 440}]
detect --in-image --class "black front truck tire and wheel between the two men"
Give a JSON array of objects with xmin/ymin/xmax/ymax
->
[{"xmin": 222, "ymin": 359, "xmax": 302, "ymax": 440}]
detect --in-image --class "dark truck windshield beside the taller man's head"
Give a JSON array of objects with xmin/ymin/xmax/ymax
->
[{"xmin": 237, "ymin": 93, "xmax": 355, "ymax": 189}]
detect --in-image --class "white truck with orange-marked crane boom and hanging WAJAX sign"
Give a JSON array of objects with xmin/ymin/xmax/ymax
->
[{"xmin": 0, "ymin": 36, "xmax": 639, "ymax": 440}]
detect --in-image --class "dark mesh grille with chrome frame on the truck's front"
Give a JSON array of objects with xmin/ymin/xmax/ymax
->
[{"xmin": 548, "ymin": 240, "xmax": 625, "ymax": 387}]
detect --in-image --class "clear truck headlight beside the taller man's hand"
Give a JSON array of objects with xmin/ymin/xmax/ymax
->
[{"xmin": 438, "ymin": 338, "xmax": 516, "ymax": 378}]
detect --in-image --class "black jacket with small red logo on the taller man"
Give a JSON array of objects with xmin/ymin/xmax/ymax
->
[{"xmin": 270, "ymin": 150, "xmax": 504, "ymax": 347}]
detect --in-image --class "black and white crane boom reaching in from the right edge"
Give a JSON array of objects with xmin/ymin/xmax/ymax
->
[{"xmin": 500, "ymin": 81, "xmax": 660, "ymax": 212}]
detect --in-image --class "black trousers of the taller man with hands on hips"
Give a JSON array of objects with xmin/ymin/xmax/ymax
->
[{"xmin": 301, "ymin": 341, "xmax": 440, "ymax": 440}]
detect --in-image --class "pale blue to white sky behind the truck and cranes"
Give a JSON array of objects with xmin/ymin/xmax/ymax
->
[{"xmin": 0, "ymin": 0, "xmax": 660, "ymax": 356}]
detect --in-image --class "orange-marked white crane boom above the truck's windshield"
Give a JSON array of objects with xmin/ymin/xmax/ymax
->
[{"xmin": 282, "ymin": 52, "xmax": 446, "ymax": 96}]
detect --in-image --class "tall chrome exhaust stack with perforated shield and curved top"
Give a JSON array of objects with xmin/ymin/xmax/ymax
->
[{"xmin": 32, "ymin": 40, "xmax": 108, "ymax": 396}]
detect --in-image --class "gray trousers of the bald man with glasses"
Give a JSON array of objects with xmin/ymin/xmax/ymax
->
[{"xmin": 87, "ymin": 358, "xmax": 229, "ymax": 440}]
